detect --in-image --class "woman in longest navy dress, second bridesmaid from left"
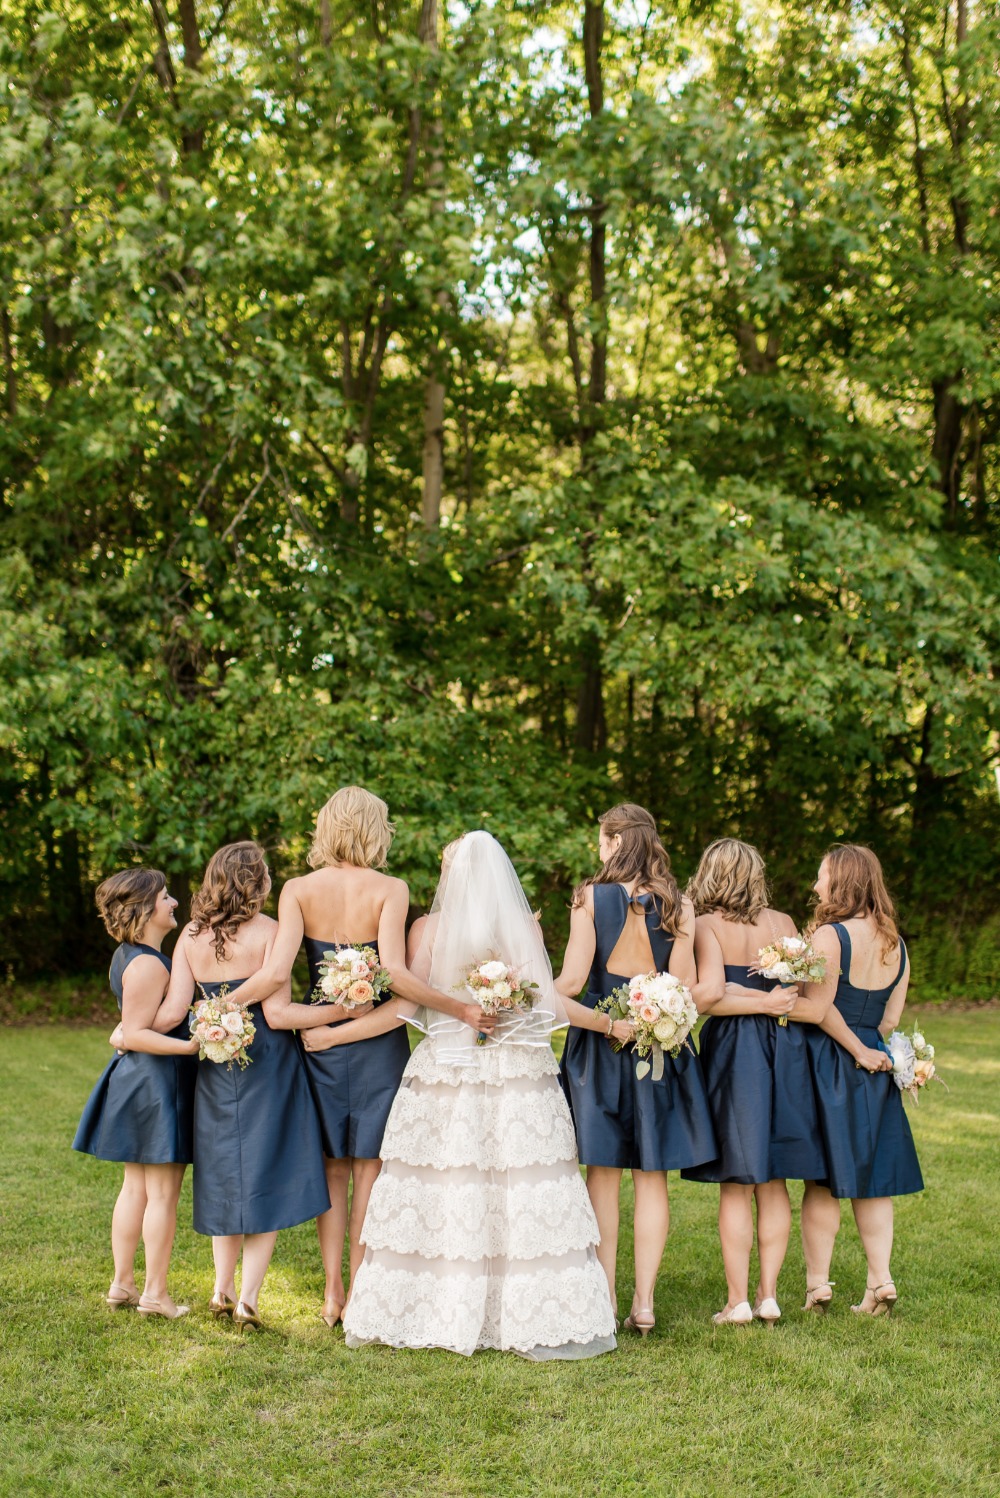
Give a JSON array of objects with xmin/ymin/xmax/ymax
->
[{"xmin": 169, "ymin": 842, "xmax": 329, "ymax": 1330}]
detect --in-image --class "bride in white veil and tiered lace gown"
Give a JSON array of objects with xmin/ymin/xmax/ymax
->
[{"xmin": 304, "ymin": 831, "xmax": 615, "ymax": 1360}]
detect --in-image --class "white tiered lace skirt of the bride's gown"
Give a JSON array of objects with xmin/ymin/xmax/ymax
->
[{"xmin": 344, "ymin": 1040, "xmax": 615, "ymax": 1359}]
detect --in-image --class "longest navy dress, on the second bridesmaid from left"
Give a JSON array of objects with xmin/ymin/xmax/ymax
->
[{"xmin": 195, "ymin": 980, "xmax": 329, "ymax": 1237}]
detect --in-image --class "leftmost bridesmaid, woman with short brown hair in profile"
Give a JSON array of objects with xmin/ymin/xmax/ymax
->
[{"xmin": 73, "ymin": 869, "xmax": 198, "ymax": 1320}]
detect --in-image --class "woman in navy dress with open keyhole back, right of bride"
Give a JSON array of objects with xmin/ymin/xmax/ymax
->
[{"xmin": 555, "ymin": 803, "xmax": 717, "ymax": 1336}]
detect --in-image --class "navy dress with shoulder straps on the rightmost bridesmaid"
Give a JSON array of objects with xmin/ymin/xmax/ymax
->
[{"xmin": 802, "ymin": 923, "xmax": 924, "ymax": 1200}]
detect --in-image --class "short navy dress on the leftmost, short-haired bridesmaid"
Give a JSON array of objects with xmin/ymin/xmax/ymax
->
[{"xmin": 73, "ymin": 941, "xmax": 198, "ymax": 1165}]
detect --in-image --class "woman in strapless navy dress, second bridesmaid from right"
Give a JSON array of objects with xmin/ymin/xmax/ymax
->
[{"xmin": 681, "ymin": 837, "xmax": 825, "ymax": 1326}]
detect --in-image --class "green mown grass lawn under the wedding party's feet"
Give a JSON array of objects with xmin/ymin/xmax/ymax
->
[{"xmin": 0, "ymin": 1011, "xmax": 1000, "ymax": 1498}]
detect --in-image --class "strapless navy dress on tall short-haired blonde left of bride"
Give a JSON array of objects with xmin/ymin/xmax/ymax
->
[{"xmin": 305, "ymin": 936, "xmax": 410, "ymax": 1159}]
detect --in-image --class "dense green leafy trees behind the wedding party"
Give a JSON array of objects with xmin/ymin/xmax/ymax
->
[{"xmin": 0, "ymin": 0, "xmax": 1000, "ymax": 995}]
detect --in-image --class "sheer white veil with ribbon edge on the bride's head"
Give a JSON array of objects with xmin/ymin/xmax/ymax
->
[{"xmin": 403, "ymin": 831, "xmax": 569, "ymax": 1065}]
